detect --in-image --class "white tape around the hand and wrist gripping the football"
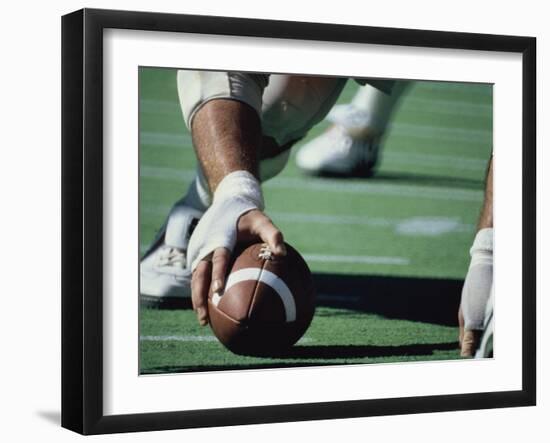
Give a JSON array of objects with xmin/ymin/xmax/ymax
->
[{"xmin": 187, "ymin": 171, "xmax": 264, "ymax": 271}]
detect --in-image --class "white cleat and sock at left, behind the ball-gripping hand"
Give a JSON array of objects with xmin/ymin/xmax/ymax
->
[{"xmin": 140, "ymin": 201, "xmax": 202, "ymax": 309}]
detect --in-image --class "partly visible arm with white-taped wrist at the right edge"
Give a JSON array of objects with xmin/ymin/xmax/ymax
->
[{"xmin": 459, "ymin": 159, "xmax": 493, "ymax": 357}]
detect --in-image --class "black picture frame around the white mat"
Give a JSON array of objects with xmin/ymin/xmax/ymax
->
[{"xmin": 62, "ymin": 9, "xmax": 536, "ymax": 434}]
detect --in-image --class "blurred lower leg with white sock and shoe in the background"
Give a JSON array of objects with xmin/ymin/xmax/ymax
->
[{"xmin": 296, "ymin": 81, "xmax": 408, "ymax": 177}]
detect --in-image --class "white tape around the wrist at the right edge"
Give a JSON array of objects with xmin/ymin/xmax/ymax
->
[{"xmin": 461, "ymin": 228, "xmax": 493, "ymax": 330}]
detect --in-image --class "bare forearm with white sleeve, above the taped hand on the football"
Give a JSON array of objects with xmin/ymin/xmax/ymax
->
[{"xmin": 177, "ymin": 70, "xmax": 269, "ymax": 193}]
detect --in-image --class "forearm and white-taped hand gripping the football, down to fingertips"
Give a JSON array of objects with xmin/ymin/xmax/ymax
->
[{"xmin": 187, "ymin": 99, "xmax": 285, "ymax": 326}]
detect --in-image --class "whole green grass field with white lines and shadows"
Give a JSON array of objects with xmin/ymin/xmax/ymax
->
[{"xmin": 140, "ymin": 68, "xmax": 492, "ymax": 374}]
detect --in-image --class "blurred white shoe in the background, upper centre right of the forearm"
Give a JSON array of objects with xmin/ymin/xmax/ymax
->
[{"xmin": 296, "ymin": 105, "xmax": 382, "ymax": 177}]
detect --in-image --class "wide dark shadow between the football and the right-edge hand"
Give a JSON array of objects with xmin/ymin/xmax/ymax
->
[{"xmin": 313, "ymin": 273, "xmax": 464, "ymax": 326}]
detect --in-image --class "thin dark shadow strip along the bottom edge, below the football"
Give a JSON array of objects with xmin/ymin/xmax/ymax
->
[{"xmin": 143, "ymin": 342, "xmax": 458, "ymax": 375}]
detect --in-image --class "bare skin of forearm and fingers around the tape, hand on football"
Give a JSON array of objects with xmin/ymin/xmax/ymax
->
[{"xmin": 191, "ymin": 99, "xmax": 285, "ymax": 325}]
